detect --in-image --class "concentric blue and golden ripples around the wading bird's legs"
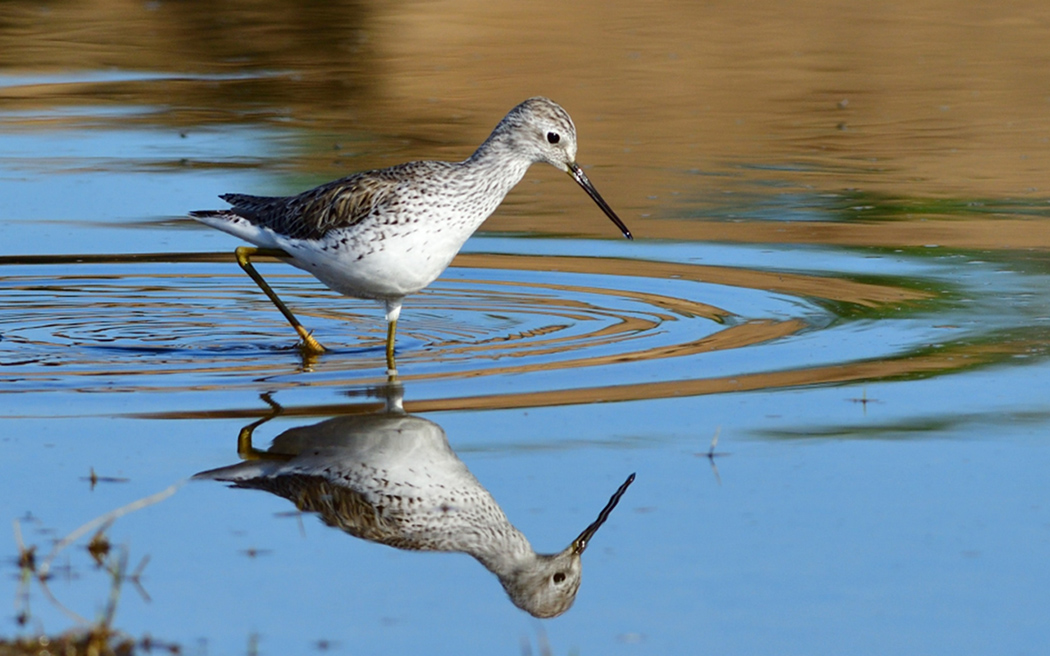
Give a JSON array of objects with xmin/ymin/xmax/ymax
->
[{"xmin": 0, "ymin": 247, "xmax": 924, "ymax": 392}]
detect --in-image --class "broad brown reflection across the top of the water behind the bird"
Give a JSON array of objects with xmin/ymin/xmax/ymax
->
[{"xmin": 8, "ymin": 0, "xmax": 1050, "ymax": 204}]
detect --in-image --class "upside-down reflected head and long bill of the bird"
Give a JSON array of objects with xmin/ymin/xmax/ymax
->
[{"xmin": 500, "ymin": 473, "xmax": 634, "ymax": 617}]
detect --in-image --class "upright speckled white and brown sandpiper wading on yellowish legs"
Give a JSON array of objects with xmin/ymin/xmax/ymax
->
[{"xmin": 190, "ymin": 98, "xmax": 632, "ymax": 374}]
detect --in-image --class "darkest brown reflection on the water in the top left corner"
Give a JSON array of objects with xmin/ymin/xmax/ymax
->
[{"xmin": 0, "ymin": 0, "xmax": 381, "ymax": 127}]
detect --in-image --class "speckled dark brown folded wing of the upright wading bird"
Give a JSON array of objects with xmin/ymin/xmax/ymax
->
[{"xmin": 221, "ymin": 167, "xmax": 401, "ymax": 239}]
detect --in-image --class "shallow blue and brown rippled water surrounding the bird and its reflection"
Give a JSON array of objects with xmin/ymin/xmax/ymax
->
[{"xmin": 0, "ymin": 2, "xmax": 1050, "ymax": 654}]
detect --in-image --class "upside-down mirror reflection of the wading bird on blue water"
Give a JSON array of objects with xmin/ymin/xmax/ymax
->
[{"xmin": 194, "ymin": 383, "xmax": 634, "ymax": 617}]
